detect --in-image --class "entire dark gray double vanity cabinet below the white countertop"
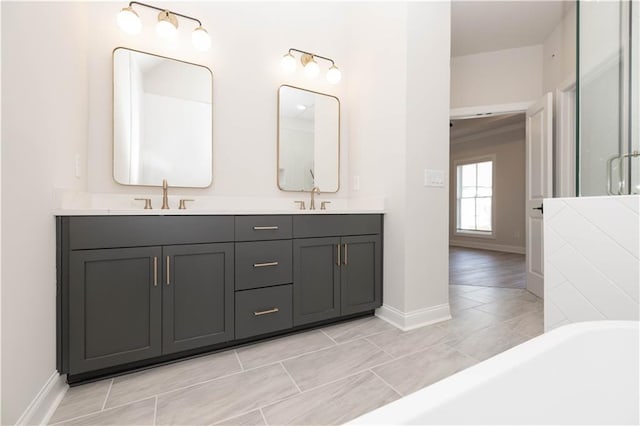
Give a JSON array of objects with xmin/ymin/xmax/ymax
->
[{"xmin": 56, "ymin": 213, "xmax": 383, "ymax": 383}]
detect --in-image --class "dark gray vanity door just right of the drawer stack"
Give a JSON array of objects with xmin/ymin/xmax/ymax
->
[{"xmin": 293, "ymin": 238, "xmax": 340, "ymax": 326}]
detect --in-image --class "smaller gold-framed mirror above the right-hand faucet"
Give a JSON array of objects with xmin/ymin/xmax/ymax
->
[{"xmin": 278, "ymin": 85, "xmax": 340, "ymax": 192}]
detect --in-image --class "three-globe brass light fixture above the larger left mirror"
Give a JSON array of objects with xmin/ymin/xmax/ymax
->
[{"xmin": 118, "ymin": 1, "xmax": 211, "ymax": 51}]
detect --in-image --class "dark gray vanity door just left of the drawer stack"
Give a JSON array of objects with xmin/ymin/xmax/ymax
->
[{"xmin": 162, "ymin": 243, "xmax": 234, "ymax": 354}]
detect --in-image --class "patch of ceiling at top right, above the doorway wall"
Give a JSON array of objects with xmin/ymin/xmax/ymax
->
[{"xmin": 451, "ymin": 0, "xmax": 575, "ymax": 56}]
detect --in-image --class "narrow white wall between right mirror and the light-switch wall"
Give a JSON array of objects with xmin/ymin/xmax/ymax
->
[{"xmin": 347, "ymin": 2, "xmax": 407, "ymax": 310}]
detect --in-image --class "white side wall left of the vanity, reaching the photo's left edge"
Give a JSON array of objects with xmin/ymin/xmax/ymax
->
[{"xmin": 2, "ymin": 2, "xmax": 88, "ymax": 424}]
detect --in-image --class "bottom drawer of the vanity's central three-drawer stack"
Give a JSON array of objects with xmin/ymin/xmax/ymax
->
[{"xmin": 236, "ymin": 284, "xmax": 293, "ymax": 339}]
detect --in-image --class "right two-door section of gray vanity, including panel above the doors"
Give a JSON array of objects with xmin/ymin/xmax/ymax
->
[{"xmin": 293, "ymin": 215, "xmax": 382, "ymax": 326}]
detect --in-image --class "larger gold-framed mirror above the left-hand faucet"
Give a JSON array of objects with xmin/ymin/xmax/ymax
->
[{"xmin": 113, "ymin": 47, "xmax": 213, "ymax": 188}]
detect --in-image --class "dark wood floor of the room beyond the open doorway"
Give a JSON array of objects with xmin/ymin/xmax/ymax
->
[{"xmin": 449, "ymin": 247, "xmax": 526, "ymax": 288}]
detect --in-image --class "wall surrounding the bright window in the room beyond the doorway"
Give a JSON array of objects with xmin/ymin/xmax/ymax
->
[{"xmin": 449, "ymin": 127, "xmax": 525, "ymax": 253}]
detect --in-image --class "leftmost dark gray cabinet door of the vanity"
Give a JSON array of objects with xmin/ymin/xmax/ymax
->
[{"xmin": 69, "ymin": 247, "xmax": 161, "ymax": 374}]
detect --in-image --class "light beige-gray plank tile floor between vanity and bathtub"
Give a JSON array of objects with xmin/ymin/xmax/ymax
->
[{"xmin": 51, "ymin": 285, "xmax": 543, "ymax": 425}]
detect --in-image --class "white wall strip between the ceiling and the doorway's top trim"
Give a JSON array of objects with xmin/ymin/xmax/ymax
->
[{"xmin": 451, "ymin": 45, "xmax": 543, "ymax": 108}]
